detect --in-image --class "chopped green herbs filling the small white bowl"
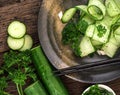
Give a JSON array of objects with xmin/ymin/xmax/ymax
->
[{"xmin": 83, "ymin": 84, "xmax": 113, "ymax": 95}]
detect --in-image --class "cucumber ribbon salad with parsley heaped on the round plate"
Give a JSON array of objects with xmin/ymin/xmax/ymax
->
[{"xmin": 61, "ymin": 0, "xmax": 120, "ymax": 58}]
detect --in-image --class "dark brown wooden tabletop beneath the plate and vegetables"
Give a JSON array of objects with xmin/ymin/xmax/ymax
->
[{"xmin": 0, "ymin": 0, "xmax": 120, "ymax": 95}]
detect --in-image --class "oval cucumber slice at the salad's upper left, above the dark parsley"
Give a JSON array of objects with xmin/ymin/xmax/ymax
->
[{"xmin": 61, "ymin": 8, "xmax": 77, "ymax": 23}]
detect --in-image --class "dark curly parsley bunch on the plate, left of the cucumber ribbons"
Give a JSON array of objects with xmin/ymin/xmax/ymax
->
[{"xmin": 62, "ymin": 20, "xmax": 88, "ymax": 56}]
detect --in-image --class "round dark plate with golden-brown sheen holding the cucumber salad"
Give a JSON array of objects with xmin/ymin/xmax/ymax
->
[{"xmin": 38, "ymin": 0, "xmax": 120, "ymax": 83}]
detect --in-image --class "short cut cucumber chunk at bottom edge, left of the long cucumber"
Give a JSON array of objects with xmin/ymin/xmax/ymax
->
[{"xmin": 24, "ymin": 81, "xmax": 48, "ymax": 95}]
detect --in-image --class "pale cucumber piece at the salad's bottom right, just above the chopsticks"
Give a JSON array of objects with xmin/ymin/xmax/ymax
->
[{"xmin": 102, "ymin": 42, "xmax": 119, "ymax": 58}]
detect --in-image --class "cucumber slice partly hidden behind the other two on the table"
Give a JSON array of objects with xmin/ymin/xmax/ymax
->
[{"xmin": 20, "ymin": 34, "xmax": 33, "ymax": 51}]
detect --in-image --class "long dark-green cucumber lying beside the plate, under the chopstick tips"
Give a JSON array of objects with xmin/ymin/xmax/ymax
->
[{"xmin": 31, "ymin": 46, "xmax": 69, "ymax": 95}]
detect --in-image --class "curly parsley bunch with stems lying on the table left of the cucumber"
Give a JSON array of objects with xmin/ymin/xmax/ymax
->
[{"xmin": 0, "ymin": 50, "xmax": 37, "ymax": 95}]
